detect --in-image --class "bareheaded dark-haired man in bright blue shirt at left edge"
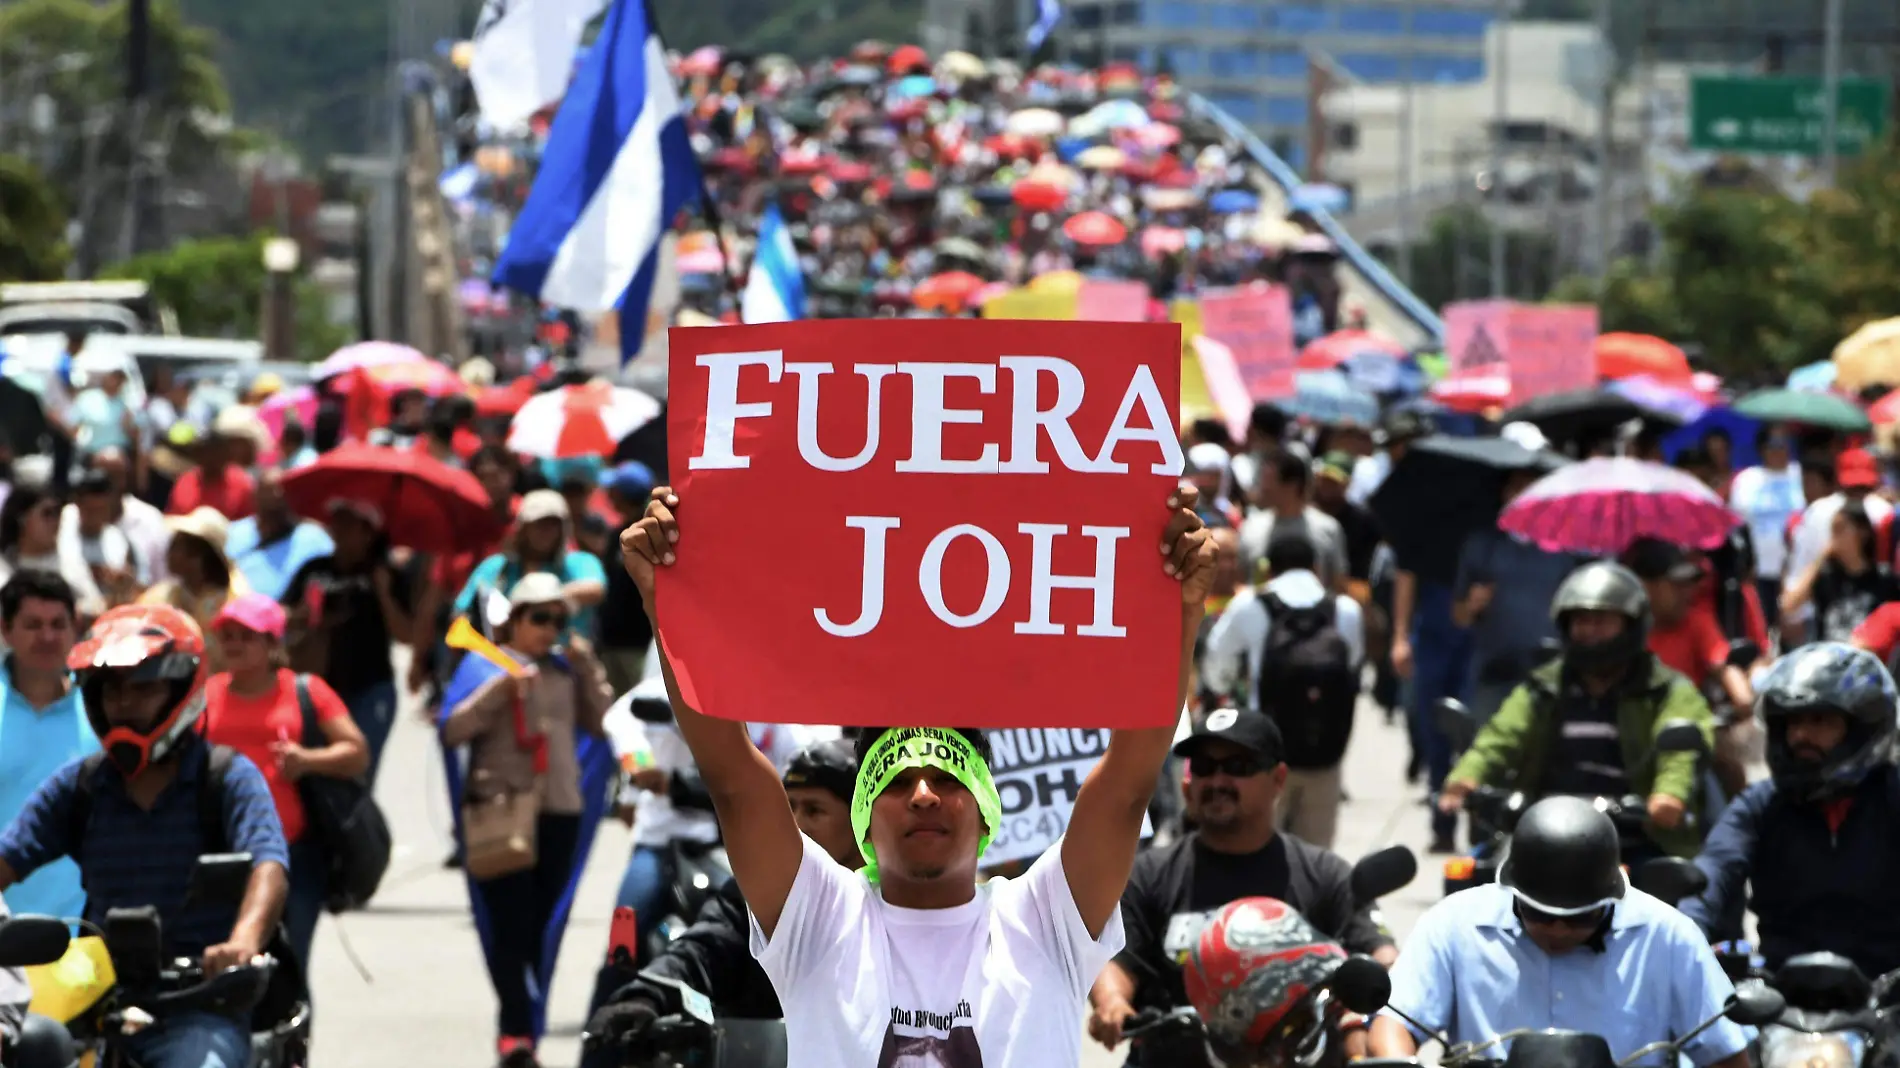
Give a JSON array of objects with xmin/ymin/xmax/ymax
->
[{"xmin": 0, "ymin": 568, "xmax": 99, "ymax": 916}]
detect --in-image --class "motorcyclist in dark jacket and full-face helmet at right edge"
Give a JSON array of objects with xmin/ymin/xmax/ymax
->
[{"xmin": 1682, "ymin": 642, "xmax": 1900, "ymax": 977}]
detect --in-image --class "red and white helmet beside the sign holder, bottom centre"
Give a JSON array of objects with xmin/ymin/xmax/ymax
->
[{"xmin": 1182, "ymin": 897, "xmax": 1345, "ymax": 1064}]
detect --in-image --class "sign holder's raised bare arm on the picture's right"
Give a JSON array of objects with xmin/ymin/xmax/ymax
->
[{"xmin": 1062, "ymin": 486, "xmax": 1216, "ymax": 939}]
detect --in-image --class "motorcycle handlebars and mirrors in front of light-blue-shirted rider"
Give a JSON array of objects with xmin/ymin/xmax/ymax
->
[{"xmin": 1355, "ymin": 982, "xmax": 1786, "ymax": 1068}]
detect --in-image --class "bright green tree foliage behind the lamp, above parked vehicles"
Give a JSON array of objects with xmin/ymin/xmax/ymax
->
[{"xmin": 99, "ymin": 234, "xmax": 348, "ymax": 359}]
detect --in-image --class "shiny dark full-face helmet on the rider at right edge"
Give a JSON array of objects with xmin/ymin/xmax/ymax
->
[{"xmin": 1756, "ymin": 642, "xmax": 1900, "ymax": 800}]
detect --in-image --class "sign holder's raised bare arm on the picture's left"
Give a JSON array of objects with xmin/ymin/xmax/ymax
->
[{"xmin": 619, "ymin": 486, "xmax": 801, "ymax": 939}]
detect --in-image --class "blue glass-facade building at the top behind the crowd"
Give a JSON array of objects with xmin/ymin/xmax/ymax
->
[{"xmin": 1056, "ymin": 0, "xmax": 1497, "ymax": 169}]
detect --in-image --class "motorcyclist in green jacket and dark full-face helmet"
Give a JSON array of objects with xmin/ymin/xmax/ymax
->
[{"xmin": 1438, "ymin": 561, "xmax": 1714, "ymax": 865}]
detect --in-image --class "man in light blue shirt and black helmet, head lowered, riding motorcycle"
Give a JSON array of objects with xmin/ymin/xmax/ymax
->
[{"xmin": 1372, "ymin": 796, "xmax": 1748, "ymax": 1068}]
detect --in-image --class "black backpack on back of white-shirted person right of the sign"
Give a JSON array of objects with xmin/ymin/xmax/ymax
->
[{"xmin": 1258, "ymin": 593, "xmax": 1359, "ymax": 768}]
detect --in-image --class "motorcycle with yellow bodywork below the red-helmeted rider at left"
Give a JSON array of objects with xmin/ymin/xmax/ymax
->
[{"xmin": 0, "ymin": 853, "xmax": 310, "ymax": 1068}]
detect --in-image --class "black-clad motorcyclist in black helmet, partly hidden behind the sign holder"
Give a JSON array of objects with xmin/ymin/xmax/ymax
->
[{"xmin": 585, "ymin": 737, "xmax": 865, "ymax": 1068}]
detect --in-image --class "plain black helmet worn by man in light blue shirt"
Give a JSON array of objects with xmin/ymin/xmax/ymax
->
[{"xmin": 1497, "ymin": 796, "xmax": 1630, "ymax": 916}]
